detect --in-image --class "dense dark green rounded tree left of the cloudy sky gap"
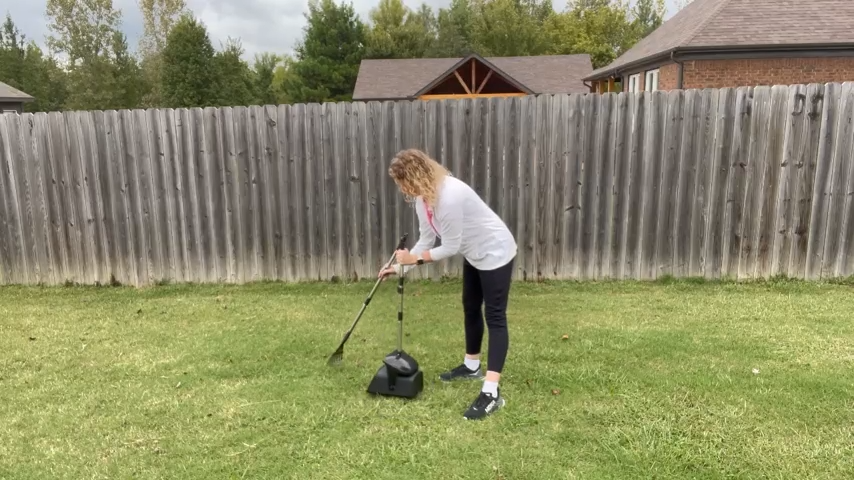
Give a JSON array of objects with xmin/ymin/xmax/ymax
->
[{"xmin": 160, "ymin": 14, "xmax": 219, "ymax": 108}]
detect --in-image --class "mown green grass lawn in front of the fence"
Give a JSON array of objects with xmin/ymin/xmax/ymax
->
[{"xmin": 0, "ymin": 281, "xmax": 854, "ymax": 480}]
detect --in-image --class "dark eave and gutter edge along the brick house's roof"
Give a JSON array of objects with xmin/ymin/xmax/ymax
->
[{"xmin": 582, "ymin": 42, "xmax": 854, "ymax": 82}]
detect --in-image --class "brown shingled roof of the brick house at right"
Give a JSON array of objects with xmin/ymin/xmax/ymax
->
[{"xmin": 584, "ymin": 0, "xmax": 854, "ymax": 80}]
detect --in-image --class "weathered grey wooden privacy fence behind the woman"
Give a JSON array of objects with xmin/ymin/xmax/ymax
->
[{"xmin": 0, "ymin": 83, "xmax": 854, "ymax": 285}]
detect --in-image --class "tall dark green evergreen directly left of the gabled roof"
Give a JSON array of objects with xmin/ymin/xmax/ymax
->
[{"xmin": 286, "ymin": 0, "xmax": 366, "ymax": 103}]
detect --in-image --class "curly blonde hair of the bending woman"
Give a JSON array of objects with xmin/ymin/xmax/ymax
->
[{"xmin": 388, "ymin": 148, "xmax": 451, "ymax": 207}]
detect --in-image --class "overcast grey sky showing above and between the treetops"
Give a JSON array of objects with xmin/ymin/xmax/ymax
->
[{"xmin": 0, "ymin": 0, "xmax": 676, "ymax": 60}]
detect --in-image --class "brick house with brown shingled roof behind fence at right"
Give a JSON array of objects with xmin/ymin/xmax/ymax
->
[{"xmin": 584, "ymin": 0, "xmax": 854, "ymax": 93}]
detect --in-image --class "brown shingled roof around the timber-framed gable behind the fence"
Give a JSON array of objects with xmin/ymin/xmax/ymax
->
[{"xmin": 353, "ymin": 54, "xmax": 593, "ymax": 101}]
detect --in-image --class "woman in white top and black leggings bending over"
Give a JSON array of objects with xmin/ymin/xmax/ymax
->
[{"xmin": 380, "ymin": 149, "xmax": 517, "ymax": 419}]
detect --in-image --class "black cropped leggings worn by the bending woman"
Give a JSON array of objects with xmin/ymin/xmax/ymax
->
[{"xmin": 463, "ymin": 260, "xmax": 513, "ymax": 373}]
